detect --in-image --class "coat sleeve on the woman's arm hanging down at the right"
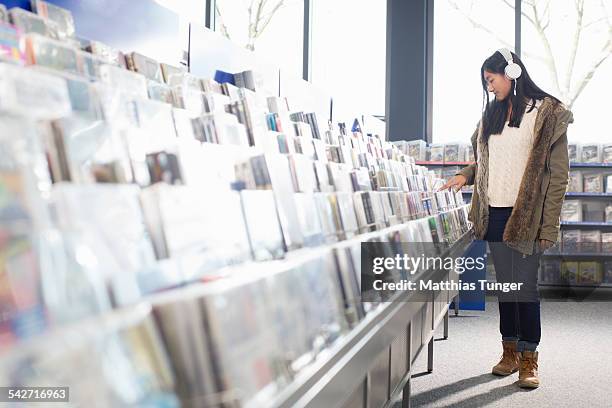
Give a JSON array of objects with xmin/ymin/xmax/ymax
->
[{"xmin": 539, "ymin": 111, "xmax": 573, "ymax": 242}]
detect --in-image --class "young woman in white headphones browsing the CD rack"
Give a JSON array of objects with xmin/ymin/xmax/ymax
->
[{"xmin": 442, "ymin": 49, "xmax": 573, "ymax": 388}]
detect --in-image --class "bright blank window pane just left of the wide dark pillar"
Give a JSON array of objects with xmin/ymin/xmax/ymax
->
[{"xmin": 312, "ymin": 0, "xmax": 387, "ymax": 119}]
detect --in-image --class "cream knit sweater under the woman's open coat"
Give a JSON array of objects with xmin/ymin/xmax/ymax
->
[{"xmin": 488, "ymin": 101, "xmax": 542, "ymax": 207}]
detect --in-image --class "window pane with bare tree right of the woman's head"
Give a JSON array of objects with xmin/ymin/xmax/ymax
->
[{"xmin": 521, "ymin": 0, "xmax": 612, "ymax": 143}]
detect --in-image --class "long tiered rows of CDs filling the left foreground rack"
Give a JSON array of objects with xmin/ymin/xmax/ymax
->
[{"xmin": 0, "ymin": 2, "xmax": 468, "ymax": 407}]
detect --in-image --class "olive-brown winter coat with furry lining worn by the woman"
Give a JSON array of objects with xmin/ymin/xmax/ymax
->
[{"xmin": 458, "ymin": 98, "xmax": 573, "ymax": 255}]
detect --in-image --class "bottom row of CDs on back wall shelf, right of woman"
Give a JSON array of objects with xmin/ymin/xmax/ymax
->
[{"xmin": 540, "ymin": 260, "xmax": 612, "ymax": 285}]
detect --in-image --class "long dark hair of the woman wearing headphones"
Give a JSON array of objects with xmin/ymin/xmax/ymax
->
[{"xmin": 480, "ymin": 51, "xmax": 560, "ymax": 141}]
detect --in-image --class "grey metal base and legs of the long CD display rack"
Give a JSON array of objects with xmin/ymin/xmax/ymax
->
[{"xmin": 267, "ymin": 231, "xmax": 472, "ymax": 408}]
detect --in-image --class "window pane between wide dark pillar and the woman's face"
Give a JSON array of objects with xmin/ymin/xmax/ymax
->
[{"xmin": 432, "ymin": 0, "xmax": 512, "ymax": 143}]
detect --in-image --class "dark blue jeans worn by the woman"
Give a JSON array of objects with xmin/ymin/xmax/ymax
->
[{"xmin": 485, "ymin": 207, "xmax": 541, "ymax": 351}]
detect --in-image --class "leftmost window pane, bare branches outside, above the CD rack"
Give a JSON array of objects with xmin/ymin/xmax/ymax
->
[{"xmin": 215, "ymin": 0, "xmax": 304, "ymax": 78}]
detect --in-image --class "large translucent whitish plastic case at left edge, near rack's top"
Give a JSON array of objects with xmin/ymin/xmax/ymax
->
[{"xmin": 0, "ymin": 64, "xmax": 71, "ymax": 119}]
